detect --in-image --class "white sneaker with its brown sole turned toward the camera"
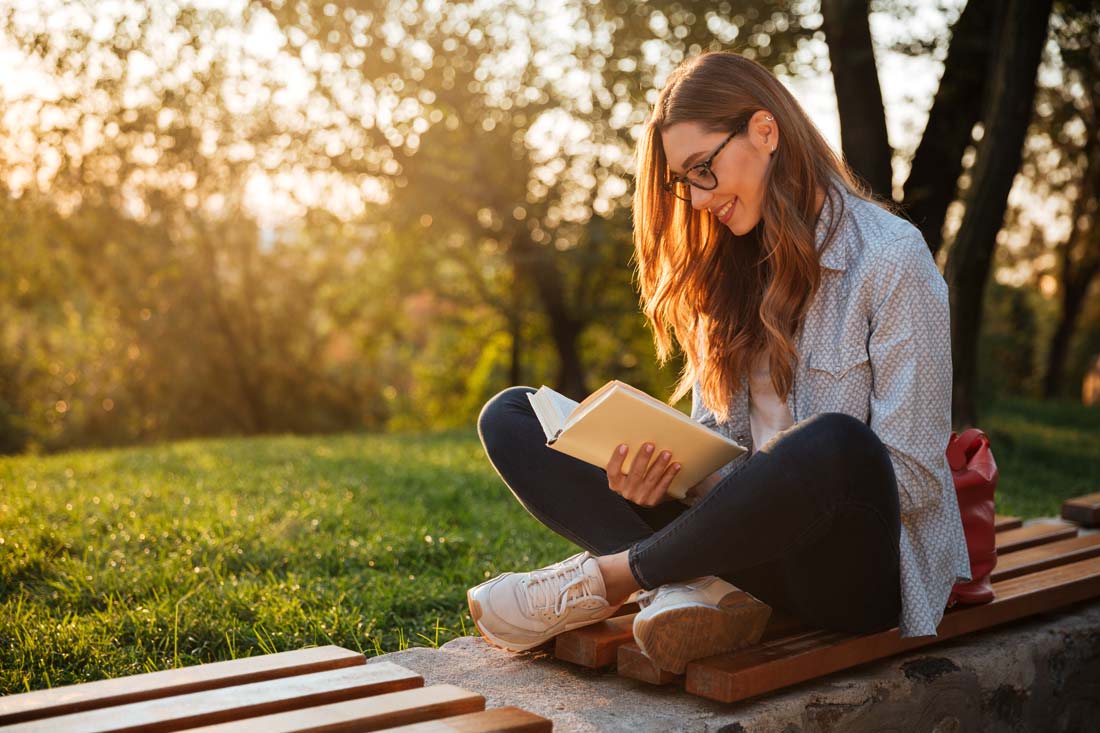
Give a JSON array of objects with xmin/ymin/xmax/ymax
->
[{"xmin": 634, "ymin": 576, "xmax": 771, "ymax": 675}]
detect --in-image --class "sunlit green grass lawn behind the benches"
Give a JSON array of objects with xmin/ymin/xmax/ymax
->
[{"xmin": 0, "ymin": 401, "xmax": 1100, "ymax": 693}]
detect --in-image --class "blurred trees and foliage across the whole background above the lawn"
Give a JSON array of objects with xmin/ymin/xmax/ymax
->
[{"xmin": 0, "ymin": 0, "xmax": 1100, "ymax": 451}]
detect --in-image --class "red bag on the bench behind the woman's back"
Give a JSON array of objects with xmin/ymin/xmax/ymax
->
[{"xmin": 947, "ymin": 428, "xmax": 998, "ymax": 608}]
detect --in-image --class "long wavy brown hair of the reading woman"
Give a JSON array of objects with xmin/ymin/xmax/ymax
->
[{"xmin": 634, "ymin": 53, "xmax": 867, "ymax": 422}]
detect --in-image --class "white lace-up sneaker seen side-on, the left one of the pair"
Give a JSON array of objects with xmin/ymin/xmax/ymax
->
[{"xmin": 466, "ymin": 551, "xmax": 622, "ymax": 652}]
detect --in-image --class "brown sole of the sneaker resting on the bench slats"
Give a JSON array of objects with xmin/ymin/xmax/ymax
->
[{"xmin": 634, "ymin": 591, "xmax": 771, "ymax": 675}]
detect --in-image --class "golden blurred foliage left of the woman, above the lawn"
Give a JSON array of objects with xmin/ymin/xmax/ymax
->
[{"xmin": 0, "ymin": 0, "xmax": 814, "ymax": 451}]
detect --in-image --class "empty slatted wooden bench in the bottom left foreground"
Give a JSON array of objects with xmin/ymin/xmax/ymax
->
[{"xmin": 0, "ymin": 646, "xmax": 552, "ymax": 733}]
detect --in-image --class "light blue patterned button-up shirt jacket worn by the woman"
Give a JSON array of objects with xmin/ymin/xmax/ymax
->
[{"xmin": 692, "ymin": 186, "xmax": 970, "ymax": 637}]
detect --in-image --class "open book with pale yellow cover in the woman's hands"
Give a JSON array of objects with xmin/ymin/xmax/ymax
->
[{"xmin": 527, "ymin": 380, "xmax": 745, "ymax": 499}]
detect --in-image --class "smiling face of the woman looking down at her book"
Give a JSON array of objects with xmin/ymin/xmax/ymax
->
[{"xmin": 661, "ymin": 110, "xmax": 779, "ymax": 236}]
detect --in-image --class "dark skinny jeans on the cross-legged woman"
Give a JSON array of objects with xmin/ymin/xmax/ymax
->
[{"xmin": 477, "ymin": 386, "xmax": 901, "ymax": 633}]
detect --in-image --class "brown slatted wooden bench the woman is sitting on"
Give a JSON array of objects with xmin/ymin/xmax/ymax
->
[{"xmin": 557, "ymin": 516, "xmax": 1100, "ymax": 702}]
